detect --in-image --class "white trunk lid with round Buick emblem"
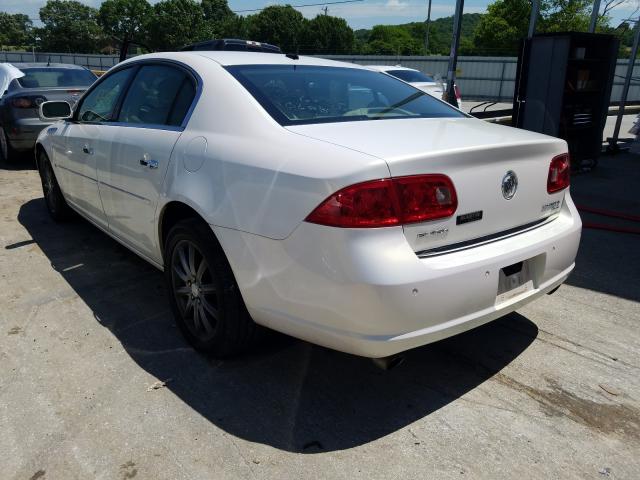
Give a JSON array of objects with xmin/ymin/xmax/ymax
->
[{"xmin": 287, "ymin": 118, "xmax": 567, "ymax": 253}]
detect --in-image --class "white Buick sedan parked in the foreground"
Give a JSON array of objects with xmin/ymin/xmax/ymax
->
[{"xmin": 36, "ymin": 52, "xmax": 581, "ymax": 357}]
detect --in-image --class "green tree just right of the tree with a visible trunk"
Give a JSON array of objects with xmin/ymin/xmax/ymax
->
[{"xmin": 147, "ymin": 0, "xmax": 209, "ymax": 51}]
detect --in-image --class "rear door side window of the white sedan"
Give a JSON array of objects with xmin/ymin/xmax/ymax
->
[{"xmin": 118, "ymin": 65, "xmax": 195, "ymax": 126}]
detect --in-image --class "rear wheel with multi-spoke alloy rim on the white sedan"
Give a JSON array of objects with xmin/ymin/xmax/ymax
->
[{"xmin": 164, "ymin": 219, "xmax": 261, "ymax": 357}]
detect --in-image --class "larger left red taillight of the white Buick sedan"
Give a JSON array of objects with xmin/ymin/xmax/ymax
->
[{"xmin": 306, "ymin": 174, "xmax": 458, "ymax": 228}]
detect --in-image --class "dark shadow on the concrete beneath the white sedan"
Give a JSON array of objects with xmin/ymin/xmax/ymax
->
[{"xmin": 17, "ymin": 199, "xmax": 538, "ymax": 453}]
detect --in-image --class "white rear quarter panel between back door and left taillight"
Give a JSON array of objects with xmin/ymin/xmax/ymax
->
[{"xmin": 159, "ymin": 58, "xmax": 389, "ymax": 239}]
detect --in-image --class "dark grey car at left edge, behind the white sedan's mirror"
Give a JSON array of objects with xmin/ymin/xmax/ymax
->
[{"xmin": 0, "ymin": 63, "xmax": 97, "ymax": 161}]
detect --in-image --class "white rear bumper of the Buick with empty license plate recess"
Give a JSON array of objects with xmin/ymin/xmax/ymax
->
[{"xmin": 214, "ymin": 194, "xmax": 581, "ymax": 357}]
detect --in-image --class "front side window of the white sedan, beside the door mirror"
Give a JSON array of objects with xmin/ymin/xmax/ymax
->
[{"xmin": 78, "ymin": 68, "xmax": 133, "ymax": 122}]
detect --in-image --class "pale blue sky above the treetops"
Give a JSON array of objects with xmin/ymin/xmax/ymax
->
[{"xmin": 0, "ymin": 0, "xmax": 640, "ymax": 29}]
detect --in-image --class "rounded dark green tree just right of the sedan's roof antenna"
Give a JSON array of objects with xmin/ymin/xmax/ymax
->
[{"xmin": 301, "ymin": 15, "xmax": 354, "ymax": 54}]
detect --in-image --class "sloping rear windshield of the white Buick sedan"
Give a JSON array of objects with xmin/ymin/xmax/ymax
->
[{"xmin": 227, "ymin": 65, "xmax": 465, "ymax": 125}]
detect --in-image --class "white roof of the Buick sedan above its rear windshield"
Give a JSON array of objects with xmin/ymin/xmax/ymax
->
[{"xmin": 123, "ymin": 50, "xmax": 365, "ymax": 69}]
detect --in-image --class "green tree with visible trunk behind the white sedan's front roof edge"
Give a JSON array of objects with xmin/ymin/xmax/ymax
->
[{"xmin": 98, "ymin": 0, "xmax": 151, "ymax": 60}]
